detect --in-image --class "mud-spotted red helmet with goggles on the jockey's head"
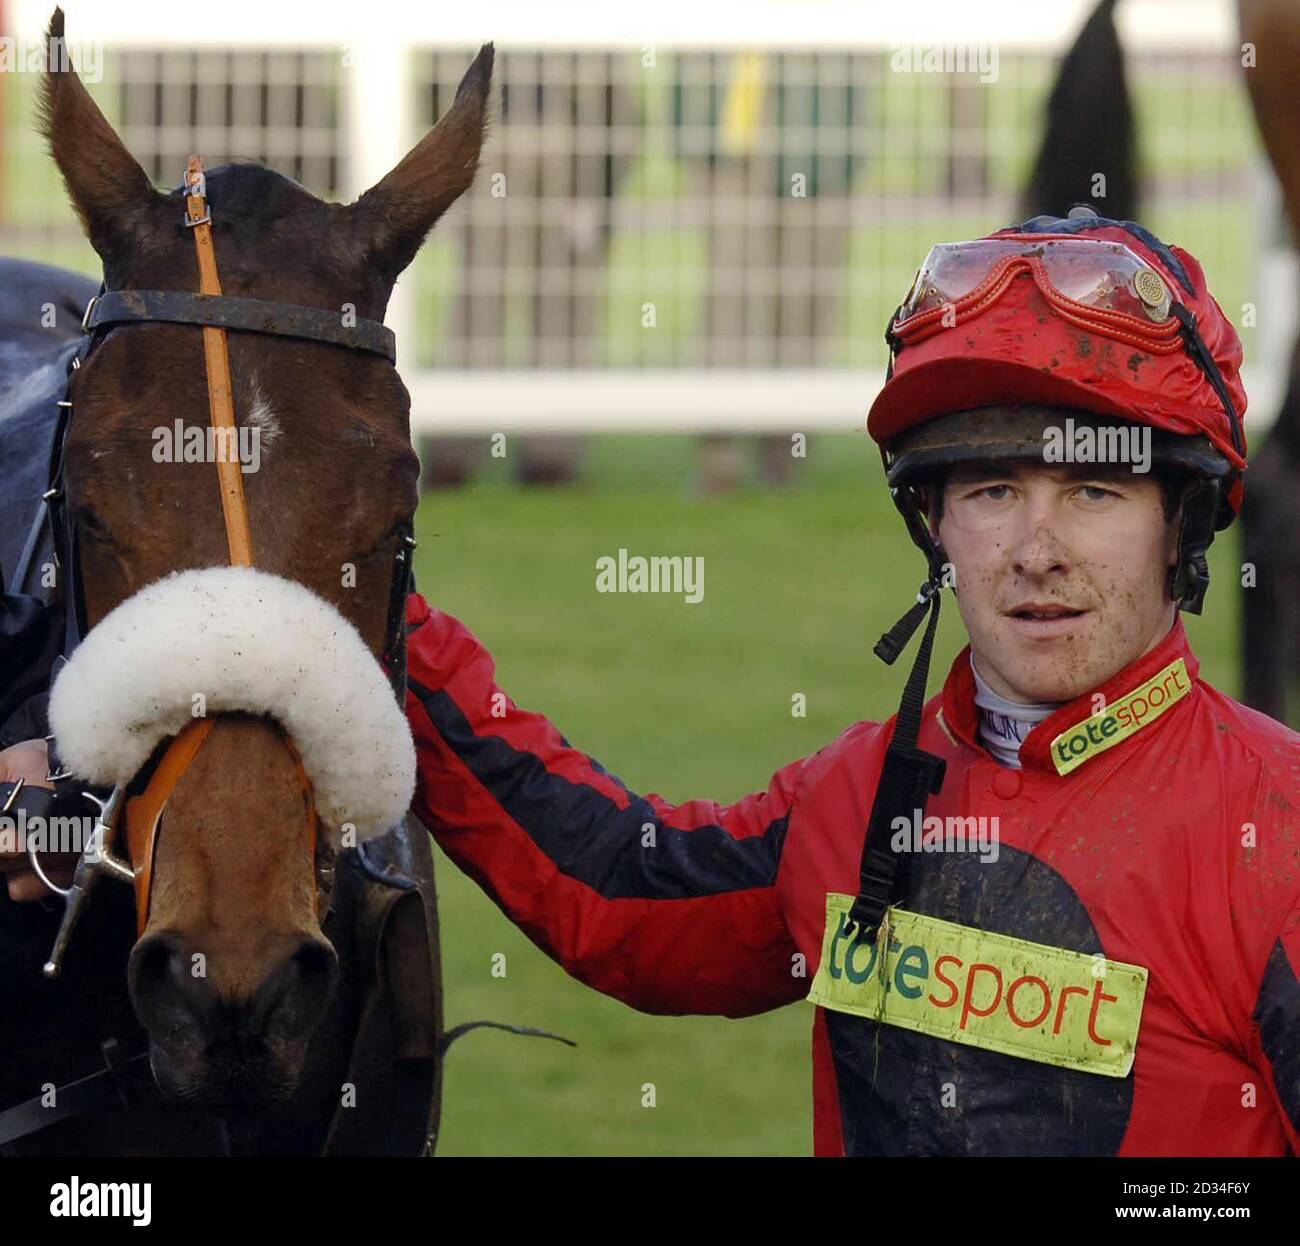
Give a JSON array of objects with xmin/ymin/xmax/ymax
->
[{"xmin": 867, "ymin": 205, "xmax": 1245, "ymax": 613}]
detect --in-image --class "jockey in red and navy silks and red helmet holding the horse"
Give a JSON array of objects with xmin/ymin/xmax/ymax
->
[{"xmin": 0, "ymin": 209, "xmax": 1300, "ymax": 1155}]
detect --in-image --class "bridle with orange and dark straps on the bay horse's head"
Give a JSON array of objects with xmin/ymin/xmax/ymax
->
[{"xmin": 25, "ymin": 156, "xmax": 415, "ymax": 978}]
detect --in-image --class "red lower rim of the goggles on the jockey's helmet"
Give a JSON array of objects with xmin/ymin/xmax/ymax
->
[{"xmin": 889, "ymin": 255, "xmax": 1183, "ymax": 355}]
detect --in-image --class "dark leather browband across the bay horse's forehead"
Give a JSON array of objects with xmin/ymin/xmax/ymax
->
[{"xmin": 82, "ymin": 290, "xmax": 397, "ymax": 363}]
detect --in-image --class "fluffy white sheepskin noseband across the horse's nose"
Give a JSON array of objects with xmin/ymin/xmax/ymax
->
[{"xmin": 49, "ymin": 567, "xmax": 415, "ymax": 839}]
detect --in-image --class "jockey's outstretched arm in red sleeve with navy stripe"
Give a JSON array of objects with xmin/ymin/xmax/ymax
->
[{"xmin": 407, "ymin": 594, "xmax": 807, "ymax": 1016}]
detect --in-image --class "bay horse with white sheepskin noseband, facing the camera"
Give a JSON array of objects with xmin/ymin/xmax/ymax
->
[{"xmin": 0, "ymin": 9, "xmax": 493, "ymax": 1155}]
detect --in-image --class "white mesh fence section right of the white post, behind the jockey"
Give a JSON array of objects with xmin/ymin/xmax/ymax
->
[{"xmin": 416, "ymin": 48, "xmax": 1256, "ymax": 368}]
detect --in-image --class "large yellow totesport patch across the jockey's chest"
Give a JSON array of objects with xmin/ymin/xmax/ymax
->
[{"xmin": 809, "ymin": 892, "xmax": 1147, "ymax": 1077}]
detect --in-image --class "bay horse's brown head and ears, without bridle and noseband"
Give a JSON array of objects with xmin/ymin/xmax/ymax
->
[{"xmin": 42, "ymin": 7, "xmax": 493, "ymax": 1104}]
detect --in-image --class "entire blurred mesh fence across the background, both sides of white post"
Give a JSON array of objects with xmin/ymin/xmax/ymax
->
[{"xmin": 0, "ymin": 37, "xmax": 1262, "ymax": 405}]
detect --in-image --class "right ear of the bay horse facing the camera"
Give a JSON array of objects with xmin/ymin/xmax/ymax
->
[{"xmin": 347, "ymin": 43, "xmax": 493, "ymax": 280}]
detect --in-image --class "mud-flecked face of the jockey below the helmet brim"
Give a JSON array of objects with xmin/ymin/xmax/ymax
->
[{"xmin": 939, "ymin": 463, "xmax": 1178, "ymax": 701}]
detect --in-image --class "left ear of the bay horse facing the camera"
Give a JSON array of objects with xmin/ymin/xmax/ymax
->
[{"xmin": 38, "ymin": 9, "xmax": 163, "ymax": 259}]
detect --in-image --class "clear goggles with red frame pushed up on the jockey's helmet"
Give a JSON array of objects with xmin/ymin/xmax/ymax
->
[{"xmin": 889, "ymin": 237, "xmax": 1183, "ymax": 354}]
